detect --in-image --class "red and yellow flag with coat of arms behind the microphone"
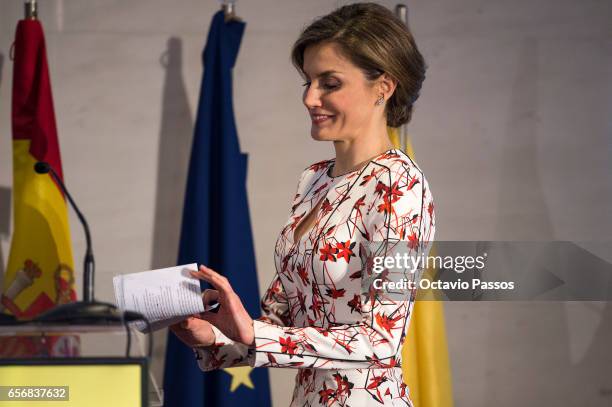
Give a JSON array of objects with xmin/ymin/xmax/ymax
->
[{"xmin": 0, "ymin": 20, "xmax": 78, "ymax": 357}]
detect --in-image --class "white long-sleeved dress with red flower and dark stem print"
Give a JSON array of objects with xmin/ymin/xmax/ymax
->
[{"xmin": 195, "ymin": 149, "xmax": 435, "ymax": 406}]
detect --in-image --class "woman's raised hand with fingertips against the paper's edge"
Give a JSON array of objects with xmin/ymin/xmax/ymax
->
[{"xmin": 191, "ymin": 266, "xmax": 255, "ymax": 346}]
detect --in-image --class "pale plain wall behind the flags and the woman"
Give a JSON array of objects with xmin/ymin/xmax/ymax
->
[{"xmin": 0, "ymin": 0, "xmax": 612, "ymax": 406}]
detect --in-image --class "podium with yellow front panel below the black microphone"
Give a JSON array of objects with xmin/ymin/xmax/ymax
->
[{"xmin": 0, "ymin": 322, "xmax": 155, "ymax": 407}]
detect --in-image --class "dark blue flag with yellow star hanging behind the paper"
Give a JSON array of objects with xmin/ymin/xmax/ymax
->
[{"xmin": 164, "ymin": 11, "xmax": 271, "ymax": 407}]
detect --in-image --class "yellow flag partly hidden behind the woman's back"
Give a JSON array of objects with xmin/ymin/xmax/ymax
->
[{"xmin": 387, "ymin": 127, "xmax": 453, "ymax": 407}]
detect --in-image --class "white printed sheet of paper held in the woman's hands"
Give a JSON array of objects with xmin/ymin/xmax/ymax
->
[{"xmin": 113, "ymin": 263, "xmax": 204, "ymax": 331}]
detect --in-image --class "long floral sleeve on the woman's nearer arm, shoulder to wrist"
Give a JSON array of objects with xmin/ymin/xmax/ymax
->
[{"xmin": 253, "ymin": 163, "xmax": 435, "ymax": 369}]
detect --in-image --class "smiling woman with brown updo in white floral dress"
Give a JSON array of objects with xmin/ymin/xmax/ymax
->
[{"xmin": 171, "ymin": 3, "xmax": 435, "ymax": 406}]
